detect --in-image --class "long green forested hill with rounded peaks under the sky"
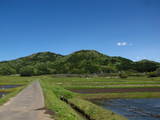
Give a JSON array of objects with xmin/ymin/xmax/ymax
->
[{"xmin": 0, "ymin": 50, "xmax": 160, "ymax": 75}]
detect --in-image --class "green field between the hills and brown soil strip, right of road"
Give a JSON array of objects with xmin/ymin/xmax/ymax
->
[{"xmin": 40, "ymin": 76, "xmax": 160, "ymax": 89}]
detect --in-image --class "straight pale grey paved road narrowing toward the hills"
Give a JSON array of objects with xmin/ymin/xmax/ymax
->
[{"xmin": 0, "ymin": 81, "xmax": 52, "ymax": 120}]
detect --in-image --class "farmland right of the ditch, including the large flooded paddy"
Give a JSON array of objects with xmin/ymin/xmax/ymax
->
[{"xmin": 41, "ymin": 76, "xmax": 160, "ymax": 120}]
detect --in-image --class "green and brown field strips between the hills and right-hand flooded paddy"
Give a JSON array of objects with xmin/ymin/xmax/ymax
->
[{"xmin": 42, "ymin": 76, "xmax": 160, "ymax": 99}]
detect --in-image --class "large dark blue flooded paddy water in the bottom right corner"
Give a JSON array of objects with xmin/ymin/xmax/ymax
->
[{"xmin": 93, "ymin": 98, "xmax": 160, "ymax": 120}]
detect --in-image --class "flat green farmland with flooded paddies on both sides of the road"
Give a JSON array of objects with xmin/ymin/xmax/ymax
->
[{"xmin": 0, "ymin": 75, "xmax": 160, "ymax": 120}]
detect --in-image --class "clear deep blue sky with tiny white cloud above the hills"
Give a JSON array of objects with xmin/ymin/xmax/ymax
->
[{"xmin": 0, "ymin": 0, "xmax": 160, "ymax": 61}]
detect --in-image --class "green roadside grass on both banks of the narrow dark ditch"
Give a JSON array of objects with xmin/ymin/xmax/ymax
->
[{"xmin": 41, "ymin": 79, "xmax": 127, "ymax": 120}]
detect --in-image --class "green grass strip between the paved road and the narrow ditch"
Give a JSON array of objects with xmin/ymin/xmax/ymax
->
[{"xmin": 41, "ymin": 81, "xmax": 82, "ymax": 120}]
